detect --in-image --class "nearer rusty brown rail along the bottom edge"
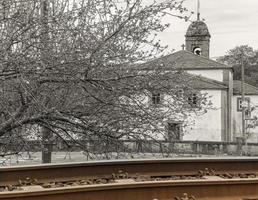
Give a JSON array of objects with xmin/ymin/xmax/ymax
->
[{"xmin": 0, "ymin": 177, "xmax": 258, "ymax": 200}]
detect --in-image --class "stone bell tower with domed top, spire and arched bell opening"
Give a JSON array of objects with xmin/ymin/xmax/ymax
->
[{"xmin": 185, "ymin": 0, "xmax": 211, "ymax": 58}]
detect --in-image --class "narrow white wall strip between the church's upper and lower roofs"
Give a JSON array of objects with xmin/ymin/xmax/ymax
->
[{"xmin": 186, "ymin": 69, "xmax": 223, "ymax": 82}]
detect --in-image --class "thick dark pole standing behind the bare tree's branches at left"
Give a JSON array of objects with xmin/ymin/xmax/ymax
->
[{"xmin": 40, "ymin": 0, "xmax": 53, "ymax": 163}]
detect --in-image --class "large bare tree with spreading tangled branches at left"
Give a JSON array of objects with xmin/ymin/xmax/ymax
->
[{"xmin": 0, "ymin": 0, "xmax": 208, "ymax": 162}]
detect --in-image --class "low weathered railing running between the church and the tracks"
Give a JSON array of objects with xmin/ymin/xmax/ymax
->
[{"xmin": 0, "ymin": 140, "xmax": 258, "ymax": 156}]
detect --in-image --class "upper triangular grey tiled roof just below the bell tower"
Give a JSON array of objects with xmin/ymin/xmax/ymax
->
[{"xmin": 136, "ymin": 50, "xmax": 233, "ymax": 70}]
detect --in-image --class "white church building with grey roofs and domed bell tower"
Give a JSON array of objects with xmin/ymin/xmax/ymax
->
[{"xmin": 144, "ymin": 9, "xmax": 258, "ymax": 143}]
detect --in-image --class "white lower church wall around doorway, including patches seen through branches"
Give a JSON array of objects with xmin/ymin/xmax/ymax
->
[{"xmin": 135, "ymin": 90, "xmax": 222, "ymax": 141}]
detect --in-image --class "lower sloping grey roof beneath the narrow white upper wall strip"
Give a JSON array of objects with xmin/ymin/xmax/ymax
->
[{"xmin": 186, "ymin": 73, "xmax": 228, "ymax": 90}]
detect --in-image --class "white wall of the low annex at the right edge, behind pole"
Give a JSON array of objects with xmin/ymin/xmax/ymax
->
[{"xmin": 232, "ymin": 95, "xmax": 258, "ymax": 143}]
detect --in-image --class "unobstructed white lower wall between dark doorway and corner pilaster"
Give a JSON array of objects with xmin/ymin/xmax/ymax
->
[{"xmin": 183, "ymin": 90, "xmax": 222, "ymax": 141}]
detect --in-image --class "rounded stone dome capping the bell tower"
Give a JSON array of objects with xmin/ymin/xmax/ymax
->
[{"xmin": 185, "ymin": 20, "xmax": 211, "ymax": 37}]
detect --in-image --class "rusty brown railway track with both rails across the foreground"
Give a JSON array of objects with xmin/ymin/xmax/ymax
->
[{"xmin": 0, "ymin": 159, "xmax": 258, "ymax": 200}]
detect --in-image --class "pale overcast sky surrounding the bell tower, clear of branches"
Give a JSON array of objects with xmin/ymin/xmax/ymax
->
[{"xmin": 159, "ymin": 0, "xmax": 258, "ymax": 57}]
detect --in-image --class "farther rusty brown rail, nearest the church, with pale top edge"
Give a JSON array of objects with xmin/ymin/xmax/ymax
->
[{"xmin": 0, "ymin": 158, "xmax": 258, "ymax": 186}]
